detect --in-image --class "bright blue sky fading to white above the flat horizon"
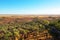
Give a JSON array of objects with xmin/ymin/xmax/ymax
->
[{"xmin": 0, "ymin": 0, "xmax": 60, "ymax": 15}]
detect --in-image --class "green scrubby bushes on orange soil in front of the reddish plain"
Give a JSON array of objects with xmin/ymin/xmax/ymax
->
[{"xmin": 0, "ymin": 17, "xmax": 60, "ymax": 40}]
